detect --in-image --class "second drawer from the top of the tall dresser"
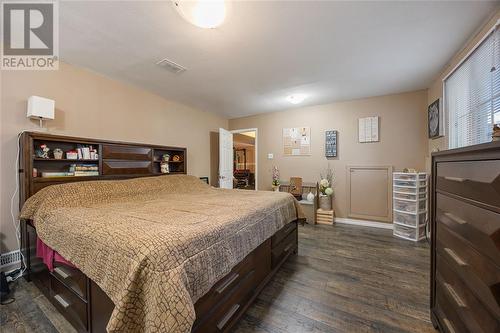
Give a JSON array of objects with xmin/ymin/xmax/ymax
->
[{"xmin": 436, "ymin": 193, "xmax": 500, "ymax": 266}]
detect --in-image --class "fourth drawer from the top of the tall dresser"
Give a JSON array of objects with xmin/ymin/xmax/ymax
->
[{"xmin": 437, "ymin": 255, "xmax": 500, "ymax": 333}]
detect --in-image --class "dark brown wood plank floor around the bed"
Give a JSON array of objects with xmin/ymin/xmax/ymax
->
[{"xmin": 0, "ymin": 224, "xmax": 436, "ymax": 333}]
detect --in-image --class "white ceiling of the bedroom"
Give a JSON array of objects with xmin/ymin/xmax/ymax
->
[{"xmin": 59, "ymin": 1, "xmax": 498, "ymax": 118}]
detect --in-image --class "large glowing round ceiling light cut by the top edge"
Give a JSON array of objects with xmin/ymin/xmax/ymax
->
[{"xmin": 172, "ymin": 0, "xmax": 227, "ymax": 29}]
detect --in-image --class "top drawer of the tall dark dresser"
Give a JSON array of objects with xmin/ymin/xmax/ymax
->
[{"xmin": 436, "ymin": 160, "xmax": 500, "ymax": 211}]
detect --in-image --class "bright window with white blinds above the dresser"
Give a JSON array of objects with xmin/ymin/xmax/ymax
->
[{"xmin": 444, "ymin": 29, "xmax": 500, "ymax": 148}]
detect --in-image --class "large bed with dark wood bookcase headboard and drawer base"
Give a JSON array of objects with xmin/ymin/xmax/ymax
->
[{"xmin": 17, "ymin": 133, "xmax": 302, "ymax": 332}]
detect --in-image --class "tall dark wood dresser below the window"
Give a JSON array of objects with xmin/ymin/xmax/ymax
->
[{"xmin": 431, "ymin": 142, "xmax": 500, "ymax": 333}]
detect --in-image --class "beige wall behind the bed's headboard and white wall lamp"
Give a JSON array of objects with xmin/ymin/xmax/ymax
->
[{"xmin": 0, "ymin": 64, "xmax": 228, "ymax": 252}]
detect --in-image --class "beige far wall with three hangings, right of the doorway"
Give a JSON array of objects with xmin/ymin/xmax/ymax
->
[{"xmin": 229, "ymin": 90, "xmax": 427, "ymax": 217}]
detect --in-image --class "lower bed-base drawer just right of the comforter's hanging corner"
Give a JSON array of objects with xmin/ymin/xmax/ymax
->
[{"xmin": 193, "ymin": 270, "xmax": 255, "ymax": 333}]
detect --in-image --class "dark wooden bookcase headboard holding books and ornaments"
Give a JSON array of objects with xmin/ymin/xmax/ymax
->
[{"xmin": 19, "ymin": 132, "xmax": 187, "ymax": 207}]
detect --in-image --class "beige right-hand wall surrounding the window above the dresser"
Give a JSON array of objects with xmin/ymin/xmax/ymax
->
[{"xmin": 426, "ymin": 10, "xmax": 500, "ymax": 170}]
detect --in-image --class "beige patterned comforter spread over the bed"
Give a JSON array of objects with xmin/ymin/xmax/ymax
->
[{"xmin": 21, "ymin": 175, "xmax": 302, "ymax": 332}]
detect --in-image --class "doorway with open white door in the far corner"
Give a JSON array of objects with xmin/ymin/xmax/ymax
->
[{"xmin": 219, "ymin": 128, "xmax": 258, "ymax": 190}]
